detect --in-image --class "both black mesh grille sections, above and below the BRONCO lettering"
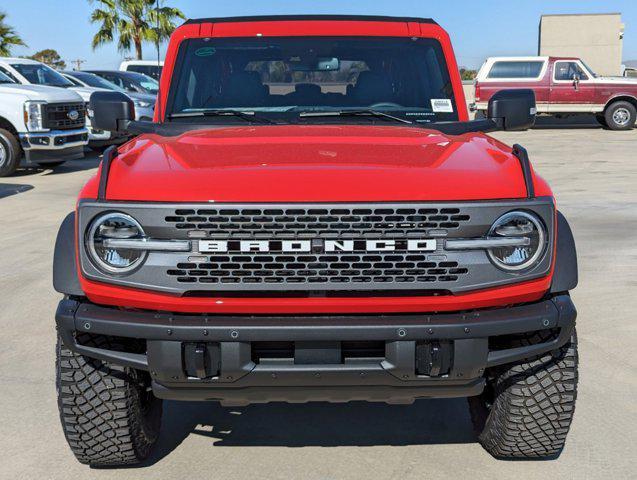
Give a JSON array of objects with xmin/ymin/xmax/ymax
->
[{"xmin": 165, "ymin": 208, "xmax": 470, "ymax": 285}]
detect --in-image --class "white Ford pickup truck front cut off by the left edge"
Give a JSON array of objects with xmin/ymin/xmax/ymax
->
[{"xmin": 0, "ymin": 71, "xmax": 88, "ymax": 177}]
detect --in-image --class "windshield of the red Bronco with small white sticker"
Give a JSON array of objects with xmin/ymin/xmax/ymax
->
[{"xmin": 169, "ymin": 37, "xmax": 458, "ymax": 123}]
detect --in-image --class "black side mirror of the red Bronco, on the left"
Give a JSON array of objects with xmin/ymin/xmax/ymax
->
[{"xmin": 89, "ymin": 92, "xmax": 135, "ymax": 132}]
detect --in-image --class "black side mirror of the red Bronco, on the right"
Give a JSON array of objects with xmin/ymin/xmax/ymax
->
[{"xmin": 487, "ymin": 89, "xmax": 537, "ymax": 131}]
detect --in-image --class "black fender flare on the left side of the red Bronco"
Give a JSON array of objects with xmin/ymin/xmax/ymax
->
[{"xmin": 53, "ymin": 212, "xmax": 84, "ymax": 296}]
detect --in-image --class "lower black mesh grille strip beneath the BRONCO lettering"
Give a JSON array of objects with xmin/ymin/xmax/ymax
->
[{"xmin": 168, "ymin": 252, "xmax": 468, "ymax": 285}]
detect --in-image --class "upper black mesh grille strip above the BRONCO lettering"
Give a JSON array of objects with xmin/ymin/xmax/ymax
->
[{"xmin": 165, "ymin": 208, "xmax": 471, "ymax": 240}]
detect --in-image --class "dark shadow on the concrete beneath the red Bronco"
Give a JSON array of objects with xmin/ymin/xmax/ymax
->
[{"xmin": 139, "ymin": 398, "xmax": 476, "ymax": 467}]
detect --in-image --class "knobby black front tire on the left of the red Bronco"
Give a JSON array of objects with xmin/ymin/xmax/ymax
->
[{"xmin": 56, "ymin": 336, "xmax": 162, "ymax": 466}]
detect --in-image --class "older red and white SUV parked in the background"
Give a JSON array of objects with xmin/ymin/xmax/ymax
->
[{"xmin": 473, "ymin": 57, "xmax": 637, "ymax": 130}]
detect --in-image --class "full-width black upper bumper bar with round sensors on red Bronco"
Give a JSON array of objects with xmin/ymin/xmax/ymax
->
[{"xmin": 56, "ymin": 295, "xmax": 575, "ymax": 342}]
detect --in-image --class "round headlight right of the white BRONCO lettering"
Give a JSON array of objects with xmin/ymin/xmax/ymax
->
[{"xmin": 488, "ymin": 212, "xmax": 546, "ymax": 271}]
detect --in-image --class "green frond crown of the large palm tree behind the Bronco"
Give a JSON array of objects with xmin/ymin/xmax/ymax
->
[{"xmin": 89, "ymin": 0, "xmax": 186, "ymax": 60}]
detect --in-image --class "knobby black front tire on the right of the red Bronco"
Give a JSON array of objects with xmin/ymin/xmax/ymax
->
[{"xmin": 469, "ymin": 330, "xmax": 577, "ymax": 459}]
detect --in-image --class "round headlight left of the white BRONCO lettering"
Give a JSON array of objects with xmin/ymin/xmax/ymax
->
[{"xmin": 86, "ymin": 213, "xmax": 148, "ymax": 273}]
